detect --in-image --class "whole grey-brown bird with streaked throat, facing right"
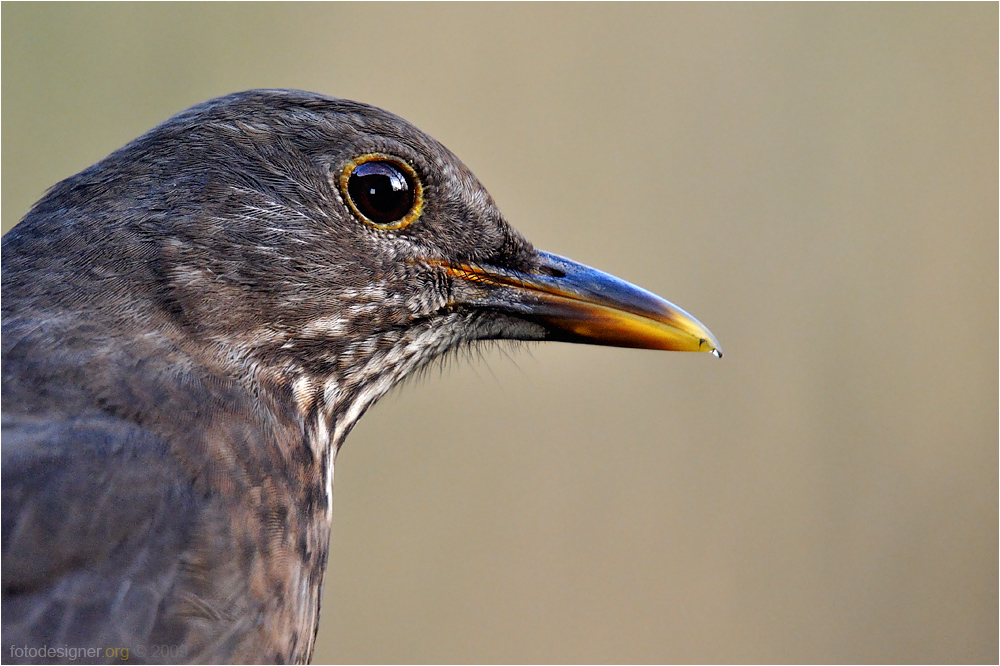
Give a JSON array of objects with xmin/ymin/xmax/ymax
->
[{"xmin": 0, "ymin": 90, "xmax": 721, "ymax": 663}]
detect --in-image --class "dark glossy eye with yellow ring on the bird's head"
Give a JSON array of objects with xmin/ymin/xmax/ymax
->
[{"xmin": 340, "ymin": 154, "xmax": 423, "ymax": 229}]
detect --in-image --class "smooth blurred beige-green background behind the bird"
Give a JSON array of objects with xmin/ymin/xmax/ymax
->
[{"xmin": 2, "ymin": 3, "xmax": 998, "ymax": 663}]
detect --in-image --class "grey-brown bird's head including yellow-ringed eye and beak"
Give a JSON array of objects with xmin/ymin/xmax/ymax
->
[{"xmin": 5, "ymin": 91, "xmax": 720, "ymax": 443}]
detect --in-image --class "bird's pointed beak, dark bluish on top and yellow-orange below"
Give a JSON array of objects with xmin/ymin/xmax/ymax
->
[{"xmin": 434, "ymin": 252, "xmax": 722, "ymax": 357}]
